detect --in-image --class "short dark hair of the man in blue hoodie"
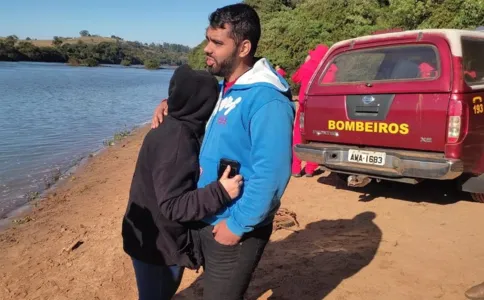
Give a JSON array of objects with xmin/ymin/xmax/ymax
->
[{"xmin": 208, "ymin": 3, "xmax": 261, "ymax": 56}]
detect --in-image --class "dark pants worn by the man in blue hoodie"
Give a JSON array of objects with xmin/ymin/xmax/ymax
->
[{"xmin": 199, "ymin": 224, "xmax": 272, "ymax": 300}]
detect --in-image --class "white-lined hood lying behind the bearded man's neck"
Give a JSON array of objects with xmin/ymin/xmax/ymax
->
[{"xmin": 232, "ymin": 58, "xmax": 289, "ymax": 93}]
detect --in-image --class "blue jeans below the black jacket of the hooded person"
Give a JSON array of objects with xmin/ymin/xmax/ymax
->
[{"xmin": 131, "ymin": 258, "xmax": 184, "ymax": 300}]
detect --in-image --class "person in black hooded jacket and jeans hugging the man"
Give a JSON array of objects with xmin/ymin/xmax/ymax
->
[{"xmin": 122, "ymin": 65, "xmax": 242, "ymax": 300}]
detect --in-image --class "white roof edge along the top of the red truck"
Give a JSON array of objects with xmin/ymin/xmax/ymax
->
[{"xmin": 332, "ymin": 29, "xmax": 484, "ymax": 57}]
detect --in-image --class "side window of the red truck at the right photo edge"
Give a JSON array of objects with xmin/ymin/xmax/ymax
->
[{"xmin": 462, "ymin": 37, "xmax": 484, "ymax": 86}]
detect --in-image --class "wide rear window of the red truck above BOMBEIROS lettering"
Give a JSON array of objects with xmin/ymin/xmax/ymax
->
[{"xmin": 319, "ymin": 45, "xmax": 440, "ymax": 84}]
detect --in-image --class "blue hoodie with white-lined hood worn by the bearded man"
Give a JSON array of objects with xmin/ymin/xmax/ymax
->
[{"xmin": 198, "ymin": 58, "xmax": 294, "ymax": 236}]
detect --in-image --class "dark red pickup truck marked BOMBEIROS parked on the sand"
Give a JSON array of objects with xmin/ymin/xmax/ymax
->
[{"xmin": 294, "ymin": 29, "xmax": 484, "ymax": 202}]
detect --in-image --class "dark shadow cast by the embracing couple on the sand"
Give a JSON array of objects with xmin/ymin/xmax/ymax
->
[{"xmin": 174, "ymin": 212, "xmax": 382, "ymax": 300}]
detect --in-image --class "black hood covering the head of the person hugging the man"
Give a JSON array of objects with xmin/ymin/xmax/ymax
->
[{"xmin": 168, "ymin": 65, "xmax": 220, "ymax": 135}]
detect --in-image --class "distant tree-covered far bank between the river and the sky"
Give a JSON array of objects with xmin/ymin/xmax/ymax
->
[{"xmin": 0, "ymin": 31, "xmax": 190, "ymax": 68}]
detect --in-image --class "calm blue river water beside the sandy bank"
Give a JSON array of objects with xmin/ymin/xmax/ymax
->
[{"xmin": 0, "ymin": 62, "xmax": 173, "ymax": 217}]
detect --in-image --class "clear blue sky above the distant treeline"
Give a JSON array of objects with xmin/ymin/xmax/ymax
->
[{"xmin": 0, "ymin": 0, "xmax": 241, "ymax": 46}]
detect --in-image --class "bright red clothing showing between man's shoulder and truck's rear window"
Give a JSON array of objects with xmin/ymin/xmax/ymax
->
[{"xmin": 291, "ymin": 45, "xmax": 329, "ymax": 103}]
